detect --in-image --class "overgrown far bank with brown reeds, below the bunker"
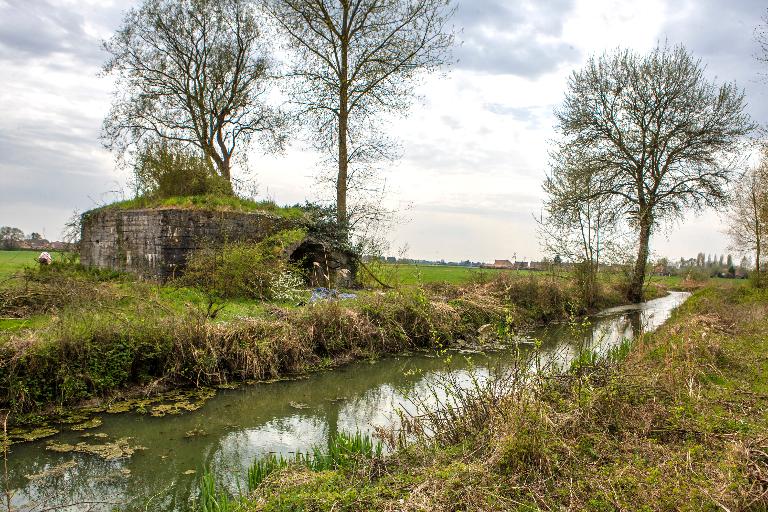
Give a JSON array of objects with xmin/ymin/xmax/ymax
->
[{"xmin": 0, "ymin": 256, "xmax": 662, "ymax": 423}]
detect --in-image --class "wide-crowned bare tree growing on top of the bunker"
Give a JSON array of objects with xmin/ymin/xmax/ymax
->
[{"xmin": 103, "ymin": 0, "xmax": 284, "ymax": 190}]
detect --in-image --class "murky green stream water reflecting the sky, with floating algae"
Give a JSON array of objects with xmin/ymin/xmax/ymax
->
[{"xmin": 0, "ymin": 292, "xmax": 688, "ymax": 512}]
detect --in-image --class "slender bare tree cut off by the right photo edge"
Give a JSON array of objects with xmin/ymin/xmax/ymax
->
[{"xmin": 728, "ymin": 154, "xmax": 768, "ymax": 288}]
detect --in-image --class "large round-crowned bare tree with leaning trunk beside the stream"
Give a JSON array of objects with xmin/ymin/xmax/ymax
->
[{"xmin": 556, "ymin": 46, "xmax": 754, "ymax": 302}]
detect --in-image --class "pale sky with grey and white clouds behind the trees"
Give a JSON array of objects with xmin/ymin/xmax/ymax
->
[{"xmin": 0, "ymin": 0, "xmax": 768, "ymax": 260}]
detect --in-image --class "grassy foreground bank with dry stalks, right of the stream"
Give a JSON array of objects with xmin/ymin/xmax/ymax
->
[{"xmin": 213, "ymin": 285, "xmax": 768, "ymax": 511}]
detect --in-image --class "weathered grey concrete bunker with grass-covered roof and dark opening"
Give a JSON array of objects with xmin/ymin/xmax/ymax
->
[{"xmin": 80, "ymin": 207, "xmax": 356, "ymax": 287}]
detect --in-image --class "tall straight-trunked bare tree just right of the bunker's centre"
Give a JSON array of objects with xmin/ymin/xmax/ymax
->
[{"xmin": 266, "ymin": 0, "xmax": 453, "ymax": 232}]
